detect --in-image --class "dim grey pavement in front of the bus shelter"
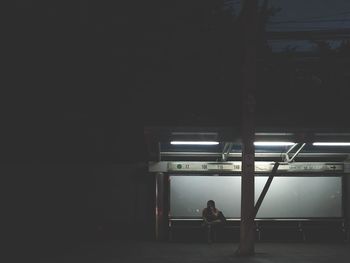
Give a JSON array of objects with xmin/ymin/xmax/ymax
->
[{"xmin": 40, "ymin": 241, "xmax": 350, "ymax": 263}]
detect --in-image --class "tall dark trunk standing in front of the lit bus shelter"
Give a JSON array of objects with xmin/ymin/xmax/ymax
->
[{"xmin": 236, "ymin": 0, "xmax": 258, "ymax": 256}]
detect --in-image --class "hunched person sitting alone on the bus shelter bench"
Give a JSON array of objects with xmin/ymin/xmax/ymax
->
[{"xmin": 202, "ymin": 200, "xmax": 226, "ymax": 243}]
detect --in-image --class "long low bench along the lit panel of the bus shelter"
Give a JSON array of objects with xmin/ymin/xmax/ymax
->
[{"xmin": 169, "ymin": 218, "xmax": 349, "ymax": 242}]
